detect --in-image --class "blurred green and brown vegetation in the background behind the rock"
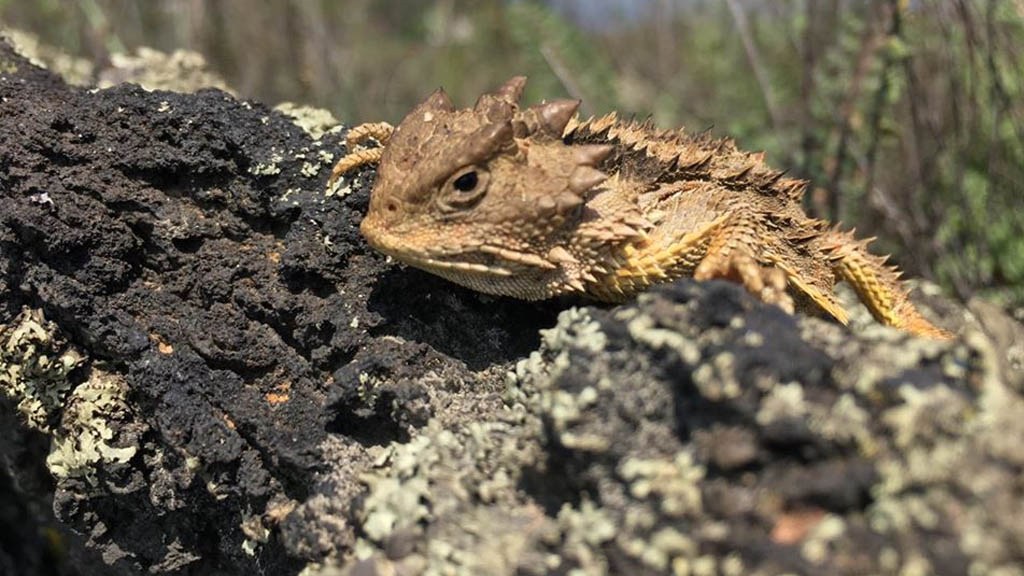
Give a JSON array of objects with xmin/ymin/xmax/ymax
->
[{"xmin": 0, "ymin": 0, "xmax": 1024, "ymax": 308}]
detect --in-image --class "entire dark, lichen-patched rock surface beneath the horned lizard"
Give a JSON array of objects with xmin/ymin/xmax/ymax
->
[{"xmin": 0, "ymin": 40, "xmax": 1024, "ymax": 576}]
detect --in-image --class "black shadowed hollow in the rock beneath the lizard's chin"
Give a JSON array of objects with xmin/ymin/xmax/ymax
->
[{"xmin": 368, "ymin": 266, "xmax": 568, "ymax": 371}]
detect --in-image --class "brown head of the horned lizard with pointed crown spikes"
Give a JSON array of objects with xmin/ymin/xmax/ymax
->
[{"xmin": 360, "ymin": 77, "xmax": 612, "ymax": 298}]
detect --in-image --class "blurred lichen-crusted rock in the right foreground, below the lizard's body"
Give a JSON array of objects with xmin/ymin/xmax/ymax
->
[{"xmin": 321, "ymin": 283, "xmax": 1024, "ymax": 575}]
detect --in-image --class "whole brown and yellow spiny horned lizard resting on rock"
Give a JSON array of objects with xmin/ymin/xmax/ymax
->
[{"xmin": 331, "ymin": 77, "xmax": 950, "ymax": 338}]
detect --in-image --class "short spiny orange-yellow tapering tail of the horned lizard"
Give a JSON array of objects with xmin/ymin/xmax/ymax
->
[{"xmin": 815, "ymin": 230, "xmax": 953, "ymax": 340}]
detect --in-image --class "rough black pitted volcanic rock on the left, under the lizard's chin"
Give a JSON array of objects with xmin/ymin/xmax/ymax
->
[{"xmin": 0, "ymin": 41, "xmax": 553, "ymax": 574}]
